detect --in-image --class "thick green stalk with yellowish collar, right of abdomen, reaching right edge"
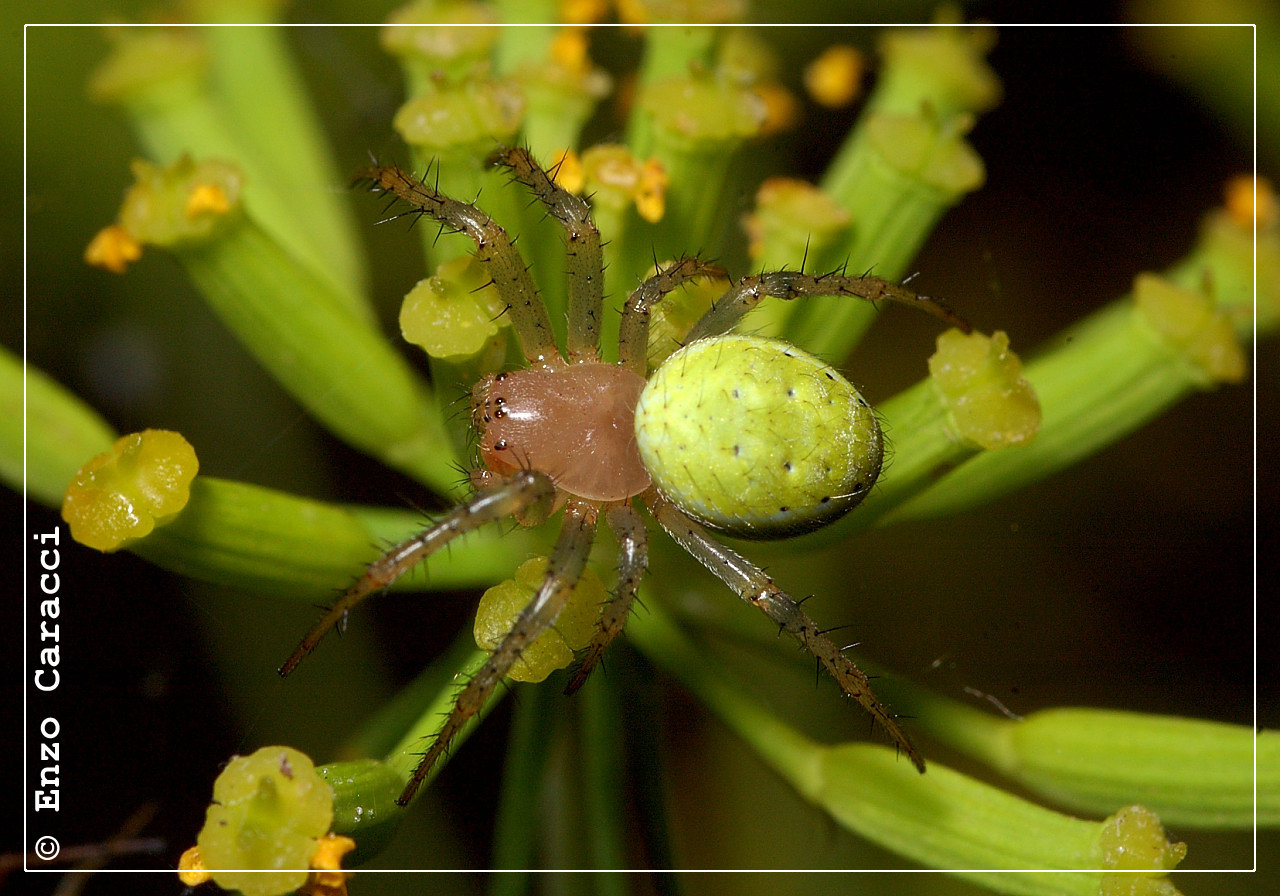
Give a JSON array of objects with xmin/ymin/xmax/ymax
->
[{"xmin": 868, "ymin": 187, "xmax": 1264, "ymax": 524}]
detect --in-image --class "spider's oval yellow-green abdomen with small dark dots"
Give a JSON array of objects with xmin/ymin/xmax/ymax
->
[{"xmin": 636, "ymin": 334, "xmax": 883, "ymax": 539}]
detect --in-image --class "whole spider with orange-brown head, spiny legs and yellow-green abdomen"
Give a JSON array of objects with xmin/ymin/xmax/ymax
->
[{"xmin": 280, "ymin": 147, "xmax": 969, "ymax": 805}]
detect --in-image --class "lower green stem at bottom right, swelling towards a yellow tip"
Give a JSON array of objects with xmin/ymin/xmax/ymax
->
[{"xmin": 627, "ymin": 604, "xmax": 1167, "ymax": 896}]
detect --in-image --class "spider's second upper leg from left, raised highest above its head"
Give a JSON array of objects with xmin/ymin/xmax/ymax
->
[{"xmin": 494, "ymin": 146, "xmax": 604, "ymax": 362}]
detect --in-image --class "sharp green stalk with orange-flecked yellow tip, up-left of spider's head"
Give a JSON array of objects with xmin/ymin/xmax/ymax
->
[{"xmin": 87, "ymin": 156, "xmax": 456, "ymax": 493}]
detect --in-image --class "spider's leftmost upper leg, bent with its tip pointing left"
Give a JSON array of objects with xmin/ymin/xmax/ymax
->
[{"xmin": 358, "ymin": 165, "xmax": 564, "ymax": 367}]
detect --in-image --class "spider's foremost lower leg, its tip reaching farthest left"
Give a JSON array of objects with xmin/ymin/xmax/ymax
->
[{"xmin": 279, "ymin": 470, "xmax": 556, "ymax": 676}]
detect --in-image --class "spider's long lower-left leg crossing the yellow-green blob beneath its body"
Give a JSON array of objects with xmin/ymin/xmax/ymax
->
[{"xmin": 396, "ymin": 499, "xmax": 596, "ymax": 805}]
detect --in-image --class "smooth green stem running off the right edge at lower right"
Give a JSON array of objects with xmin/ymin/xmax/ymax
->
[{"xmin": 675, "ymin": 593, "xmax": 1264, "ymax": 829}]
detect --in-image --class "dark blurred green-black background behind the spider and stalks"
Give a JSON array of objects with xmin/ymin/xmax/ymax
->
[{"xmin": 0, "ymin": 1, "xmax": 1280, "ymax": 895}]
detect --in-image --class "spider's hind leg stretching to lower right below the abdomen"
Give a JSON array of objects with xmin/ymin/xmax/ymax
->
[{"xmin": 644, "ymin": 489, "xmax": 924, "ymax": 773}]
